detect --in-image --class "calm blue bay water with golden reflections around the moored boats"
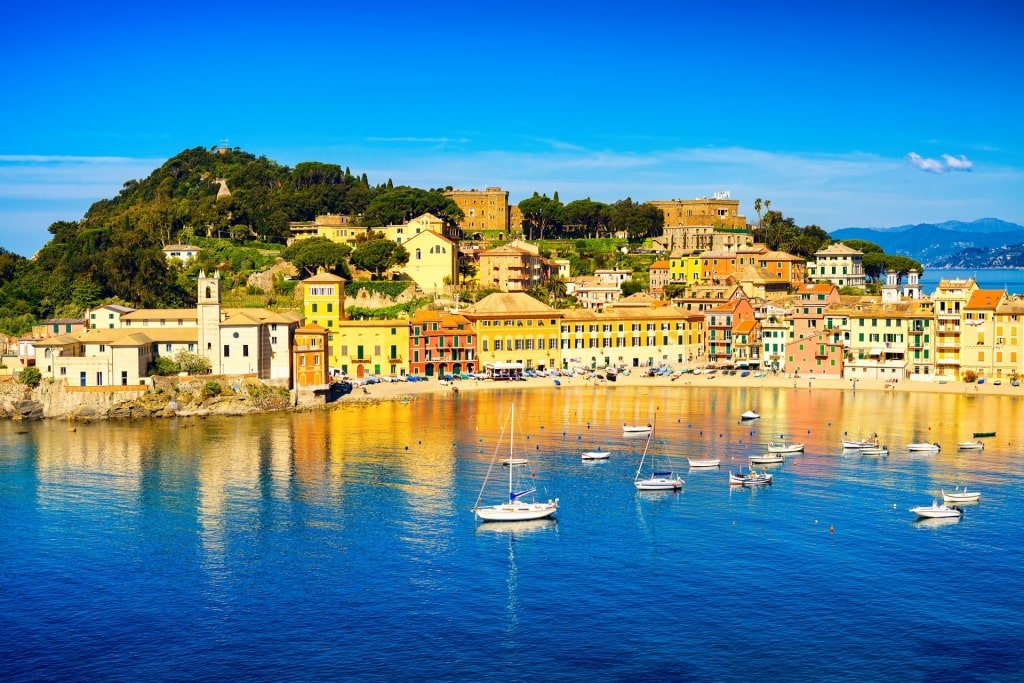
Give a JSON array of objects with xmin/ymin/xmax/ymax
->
[{"xmin": 0, "ymin": 385, "xmax": 1024, "ymax": 681}]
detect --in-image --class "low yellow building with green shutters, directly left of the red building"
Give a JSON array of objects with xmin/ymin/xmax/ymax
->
[{"xmin": 332, "ymin": 318, "xmax": 410, "ymax": 379}]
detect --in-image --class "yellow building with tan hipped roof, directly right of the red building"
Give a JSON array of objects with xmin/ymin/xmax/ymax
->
[{"xmin": 462, "ymin": 293, "xmax": 565, "ymax": 370}]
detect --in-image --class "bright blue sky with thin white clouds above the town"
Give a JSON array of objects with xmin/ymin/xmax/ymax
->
[{"xmin": 0, "ymin": 0, "xmax": 1024, "ymax": 256}]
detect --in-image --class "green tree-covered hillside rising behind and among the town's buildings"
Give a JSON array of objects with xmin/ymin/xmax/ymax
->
[{"xmin": 0, "ymin": 147, "xmax": 917, "ymax": 335}]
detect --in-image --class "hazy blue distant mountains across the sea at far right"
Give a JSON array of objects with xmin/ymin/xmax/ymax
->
[{"xmin": 829, "ymin": 218, "xmax": 1024, "ymax": 268}]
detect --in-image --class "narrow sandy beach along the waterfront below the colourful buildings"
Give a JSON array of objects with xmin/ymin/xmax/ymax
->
[{"xmin": 336, "ymin": 373, "xmax": 1024, "ymax": 404}]
